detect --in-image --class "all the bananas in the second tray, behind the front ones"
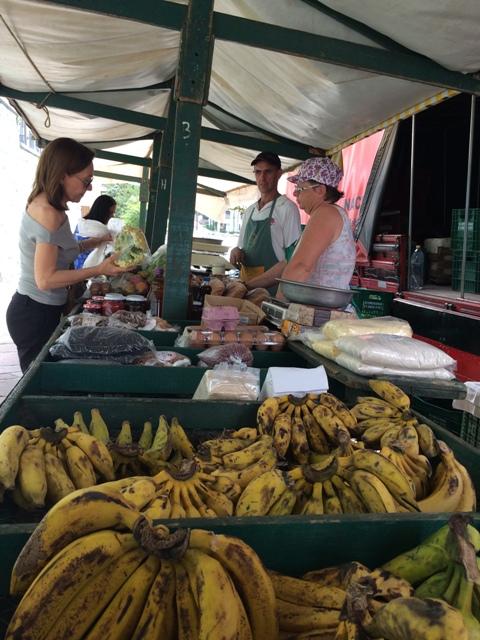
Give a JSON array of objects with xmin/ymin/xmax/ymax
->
[{"xmin": 0, "ymin": 380, "xmax": 476, "ymax": 519}]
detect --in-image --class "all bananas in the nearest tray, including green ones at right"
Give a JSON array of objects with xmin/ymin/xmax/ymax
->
[{"xmin": 5, "ymin": 481, "xmax": 480, "ymax": 640}]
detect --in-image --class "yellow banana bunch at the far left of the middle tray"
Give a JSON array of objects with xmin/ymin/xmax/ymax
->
[{"xmin": 0, "ymin": 420, "xmax": 114, "ymax": 509}]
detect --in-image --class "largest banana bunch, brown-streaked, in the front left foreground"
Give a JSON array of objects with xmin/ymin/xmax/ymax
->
[{"xmin": 5, "ymin": 481, "xmax": 278, "ymax": 640}]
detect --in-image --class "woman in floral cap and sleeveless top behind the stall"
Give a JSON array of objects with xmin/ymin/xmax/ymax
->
[{"xmin": 282, "ymin": 157, "xmax": 356, "ymax": 289}]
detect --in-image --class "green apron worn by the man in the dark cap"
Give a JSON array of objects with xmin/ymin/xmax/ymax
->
[{"xmin": 240, "ymin": 196, "xmax": 278, "ymax": 295}]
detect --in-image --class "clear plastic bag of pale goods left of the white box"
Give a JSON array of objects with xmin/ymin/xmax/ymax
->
[{"xmin": 193, "ymin": 362, "xmax": 260, "ymax": 401}]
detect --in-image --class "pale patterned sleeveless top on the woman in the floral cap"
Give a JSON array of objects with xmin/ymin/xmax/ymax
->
[{"xmin": 307, "ymin": 204, "xmax": 356, "ymax": 289}]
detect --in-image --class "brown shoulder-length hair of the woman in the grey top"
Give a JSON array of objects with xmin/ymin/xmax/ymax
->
[{"xmin": 27, "ymin": 138, "xmax": 95, "ymax": 211}]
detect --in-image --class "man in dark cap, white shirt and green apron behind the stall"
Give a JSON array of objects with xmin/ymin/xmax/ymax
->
[{"xmin": 230, "ymin": 151, "xmax": 301, "ymax": 293}]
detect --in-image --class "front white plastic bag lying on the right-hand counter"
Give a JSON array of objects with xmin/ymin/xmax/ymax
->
[{"xmin": 335, "ymin": 334, "xmax": 456, "ymax": 369}]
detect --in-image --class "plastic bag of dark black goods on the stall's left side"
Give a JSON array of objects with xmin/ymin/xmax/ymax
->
[{"xmin": 50, "ymin": 327, "xmax": 155, "ymax": 364}]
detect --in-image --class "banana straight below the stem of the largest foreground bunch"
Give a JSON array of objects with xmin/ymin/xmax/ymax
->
[{"xmin": 131, "ymin": 560, "xmax": 177, "ymax": 640}]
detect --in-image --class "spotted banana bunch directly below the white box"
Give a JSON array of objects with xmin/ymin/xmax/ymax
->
[{"xmin": 257, "ymin": 393, "xmax": 357, "ymax": 464}]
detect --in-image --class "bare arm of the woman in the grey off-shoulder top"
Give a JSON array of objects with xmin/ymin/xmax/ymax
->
[{"xmin": 34, "ymin": 242, "xmax": 127, "ymax": 291}]
